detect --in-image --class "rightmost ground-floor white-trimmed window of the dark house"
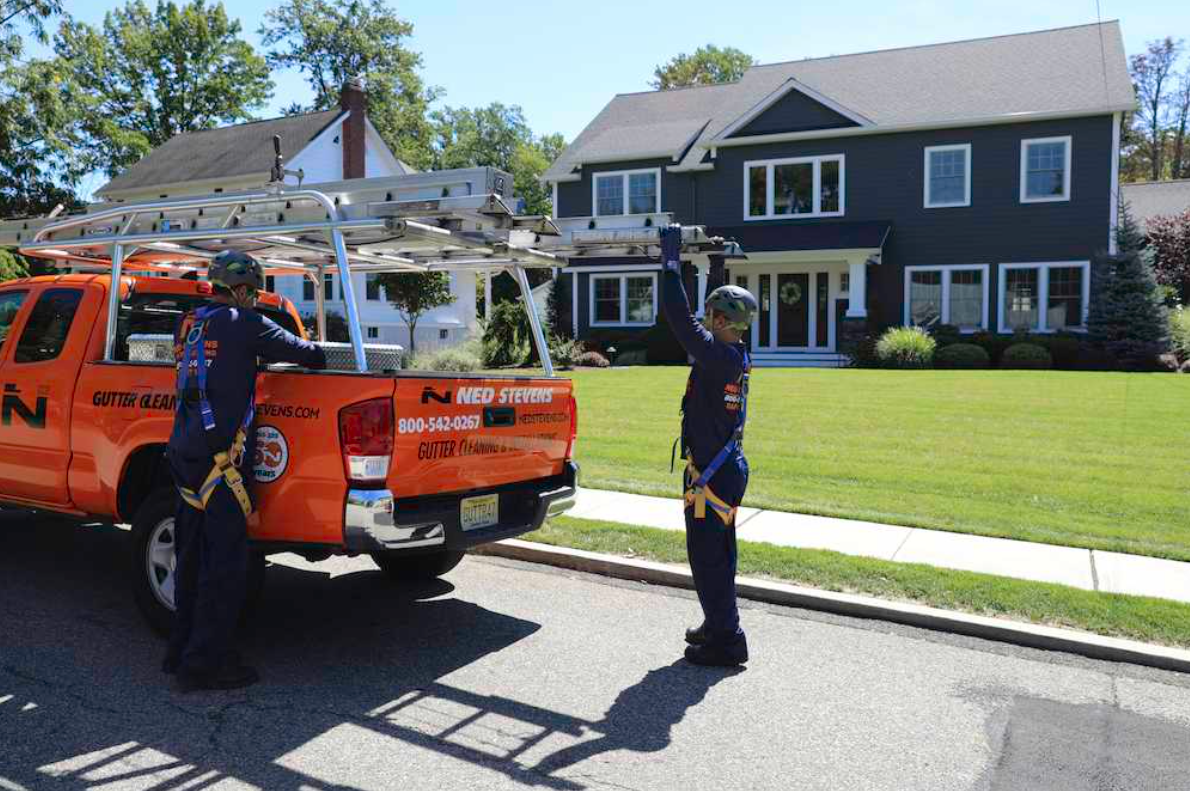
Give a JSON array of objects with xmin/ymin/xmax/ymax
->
[{"xmin": 1000, "ymin": 260, "xmax": 1091, "ymax": 332}]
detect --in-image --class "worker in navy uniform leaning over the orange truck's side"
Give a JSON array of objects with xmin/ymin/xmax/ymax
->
[{"xmin": 163, "ymin": 250, "xmax": 326, "ymax": 691}]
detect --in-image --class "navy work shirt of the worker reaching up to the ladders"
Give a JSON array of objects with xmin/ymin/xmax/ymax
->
[{"xmin": 660, "ymin": 270, "xmax": 747, "ymax": 490}]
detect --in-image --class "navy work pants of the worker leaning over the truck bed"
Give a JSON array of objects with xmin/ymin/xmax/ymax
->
[{"xmin": 169, "ymin": 483, "xmax": 249, "ymax": 676}]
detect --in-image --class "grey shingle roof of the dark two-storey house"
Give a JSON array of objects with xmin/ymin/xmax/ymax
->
[{"xmin": 543, "ymin": 21, "xmax": 1134, "ymax": 180}]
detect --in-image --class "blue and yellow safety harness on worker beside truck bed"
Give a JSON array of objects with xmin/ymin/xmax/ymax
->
[{"xmin": 177, "ymin": 306, "xmax": 256, "ymax": 519}]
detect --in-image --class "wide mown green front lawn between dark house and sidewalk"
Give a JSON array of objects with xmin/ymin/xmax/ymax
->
[{"xmin": 571, "ymin": 368, "xmax": 1190, "ymax": 560}]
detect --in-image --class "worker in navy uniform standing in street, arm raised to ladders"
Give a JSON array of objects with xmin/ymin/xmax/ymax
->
[{"xmin": 660, "ymin": 226, "xmax": 757, "ymax": 666}]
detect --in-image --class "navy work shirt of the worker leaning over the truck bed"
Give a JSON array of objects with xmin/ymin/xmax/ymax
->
[{"xmin": 167, "ymin": 303, "xmax": 326, "ymax": 489}]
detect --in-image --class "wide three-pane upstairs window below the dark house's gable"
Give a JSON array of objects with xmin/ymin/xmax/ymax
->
[{"xmin": 744, "ymin": 153, "xmax": 846, "ymax": 220}]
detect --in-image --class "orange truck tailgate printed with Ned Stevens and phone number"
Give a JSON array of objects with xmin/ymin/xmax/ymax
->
[{"xmin": 388, "ymin": 375, "xmax": 575, "ymax": 497}]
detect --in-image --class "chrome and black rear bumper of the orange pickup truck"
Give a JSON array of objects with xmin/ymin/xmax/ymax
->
[{"xmin": 343, "ymin": 462, "xmax": 578, "ymax": 553}]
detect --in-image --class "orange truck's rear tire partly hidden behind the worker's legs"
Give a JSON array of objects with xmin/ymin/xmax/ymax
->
[{"xmin": 131, "ymin": 489, "xmax": 265, "ymax": 636}]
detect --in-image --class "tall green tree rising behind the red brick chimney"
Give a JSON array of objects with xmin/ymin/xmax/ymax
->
[{"xmin": 259, "ymin": 0, "xmax": 441, "ymax": 169}]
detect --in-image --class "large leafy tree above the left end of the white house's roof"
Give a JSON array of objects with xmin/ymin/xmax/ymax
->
[{"xmin": 55, "ymin": 0, "xmax": 273, "ymax": 176}]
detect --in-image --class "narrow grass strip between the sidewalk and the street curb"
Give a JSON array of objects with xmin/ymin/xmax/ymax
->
[{"xmin": 533, "ymin": 517, "xmax": 1190, "ymax": 647}]
